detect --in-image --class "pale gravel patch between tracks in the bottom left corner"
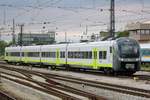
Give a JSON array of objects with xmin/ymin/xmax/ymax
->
[{"xmin": 1, "ymin": 78, "xmax": 61, "ymax": 100}]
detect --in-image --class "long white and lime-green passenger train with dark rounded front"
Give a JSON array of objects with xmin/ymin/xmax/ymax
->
[{"xmin": 5, "ymin": 38, "xmax": 141, "ymax": 74}]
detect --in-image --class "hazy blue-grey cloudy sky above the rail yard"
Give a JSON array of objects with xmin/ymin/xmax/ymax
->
[{"xmin": 0, "ymin": 0, "xmax": 150, "ymax": 41}]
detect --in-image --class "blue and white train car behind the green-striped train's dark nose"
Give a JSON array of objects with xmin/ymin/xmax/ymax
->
[{"xmin": 140, "ymin": 43, "xmax": 150, "ymax": 64}]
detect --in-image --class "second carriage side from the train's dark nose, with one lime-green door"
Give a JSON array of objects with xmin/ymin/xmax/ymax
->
[{"xmin": 41, "ymin": 44, "xmax": 66, "ymax": 66}]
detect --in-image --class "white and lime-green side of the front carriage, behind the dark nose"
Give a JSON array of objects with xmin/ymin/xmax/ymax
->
[{"xmin": 67, "ymin": 42, "xmax": 112, "ymax": 69}]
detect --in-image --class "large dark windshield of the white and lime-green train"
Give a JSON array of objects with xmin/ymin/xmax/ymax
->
[{"xmin": 118, "ymin": 40, "xmax": 140, "ymax": 58}]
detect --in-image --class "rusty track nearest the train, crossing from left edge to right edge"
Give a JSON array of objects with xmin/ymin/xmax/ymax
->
[{"xmin": 0, "ymin": 62, "xmax": 150, "ymax": 98}]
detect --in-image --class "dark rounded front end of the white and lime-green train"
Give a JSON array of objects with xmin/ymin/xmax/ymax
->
[{"xmin": 114, "ymin": 38, "xmax": 141, "ymax": 74}]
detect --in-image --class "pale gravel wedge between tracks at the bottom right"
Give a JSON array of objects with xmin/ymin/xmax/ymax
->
[{"xmin": 52, "ymin": 80, "xmax": 150, "ymax": 100}]
